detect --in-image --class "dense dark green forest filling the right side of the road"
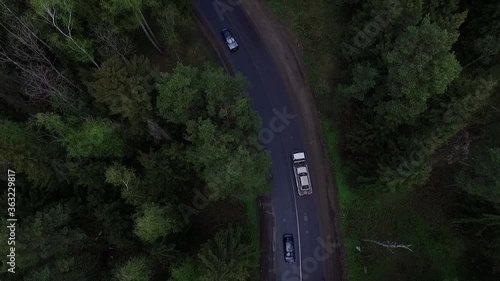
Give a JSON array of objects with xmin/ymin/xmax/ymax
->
[{"xmin": 336, "ymin": 0, "xmax": 500, "ymax": 280}]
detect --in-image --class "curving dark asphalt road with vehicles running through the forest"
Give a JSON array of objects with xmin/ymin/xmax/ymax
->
[{"xmin": 194, "ymin": 0, "xmax": 334, "ymax": 281}]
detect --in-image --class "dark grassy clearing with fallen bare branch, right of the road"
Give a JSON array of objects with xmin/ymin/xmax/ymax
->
[{"xmin": 321, "ymin": 121, "xmax": 465, "ymax": 281}]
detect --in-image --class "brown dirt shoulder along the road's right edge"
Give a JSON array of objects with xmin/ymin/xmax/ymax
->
[{"xmin": 241, "ymin": 0, "xmax": 346, "ymax": 281}]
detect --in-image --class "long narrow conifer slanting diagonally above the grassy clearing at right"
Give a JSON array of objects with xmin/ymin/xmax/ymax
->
[{"xmin": 376, "ymin": 77, "xmax": 496, "ymax": 191}]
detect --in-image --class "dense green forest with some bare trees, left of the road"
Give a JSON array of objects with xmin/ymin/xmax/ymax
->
[{"xmin": 0, "ymin": 0, "xmax": 270, "ymax": 281}]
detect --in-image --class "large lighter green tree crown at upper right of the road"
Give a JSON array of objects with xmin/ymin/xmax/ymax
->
[{"xmin": 376, "ymin": 18, "xmax": 460, "ymax": 127}]
